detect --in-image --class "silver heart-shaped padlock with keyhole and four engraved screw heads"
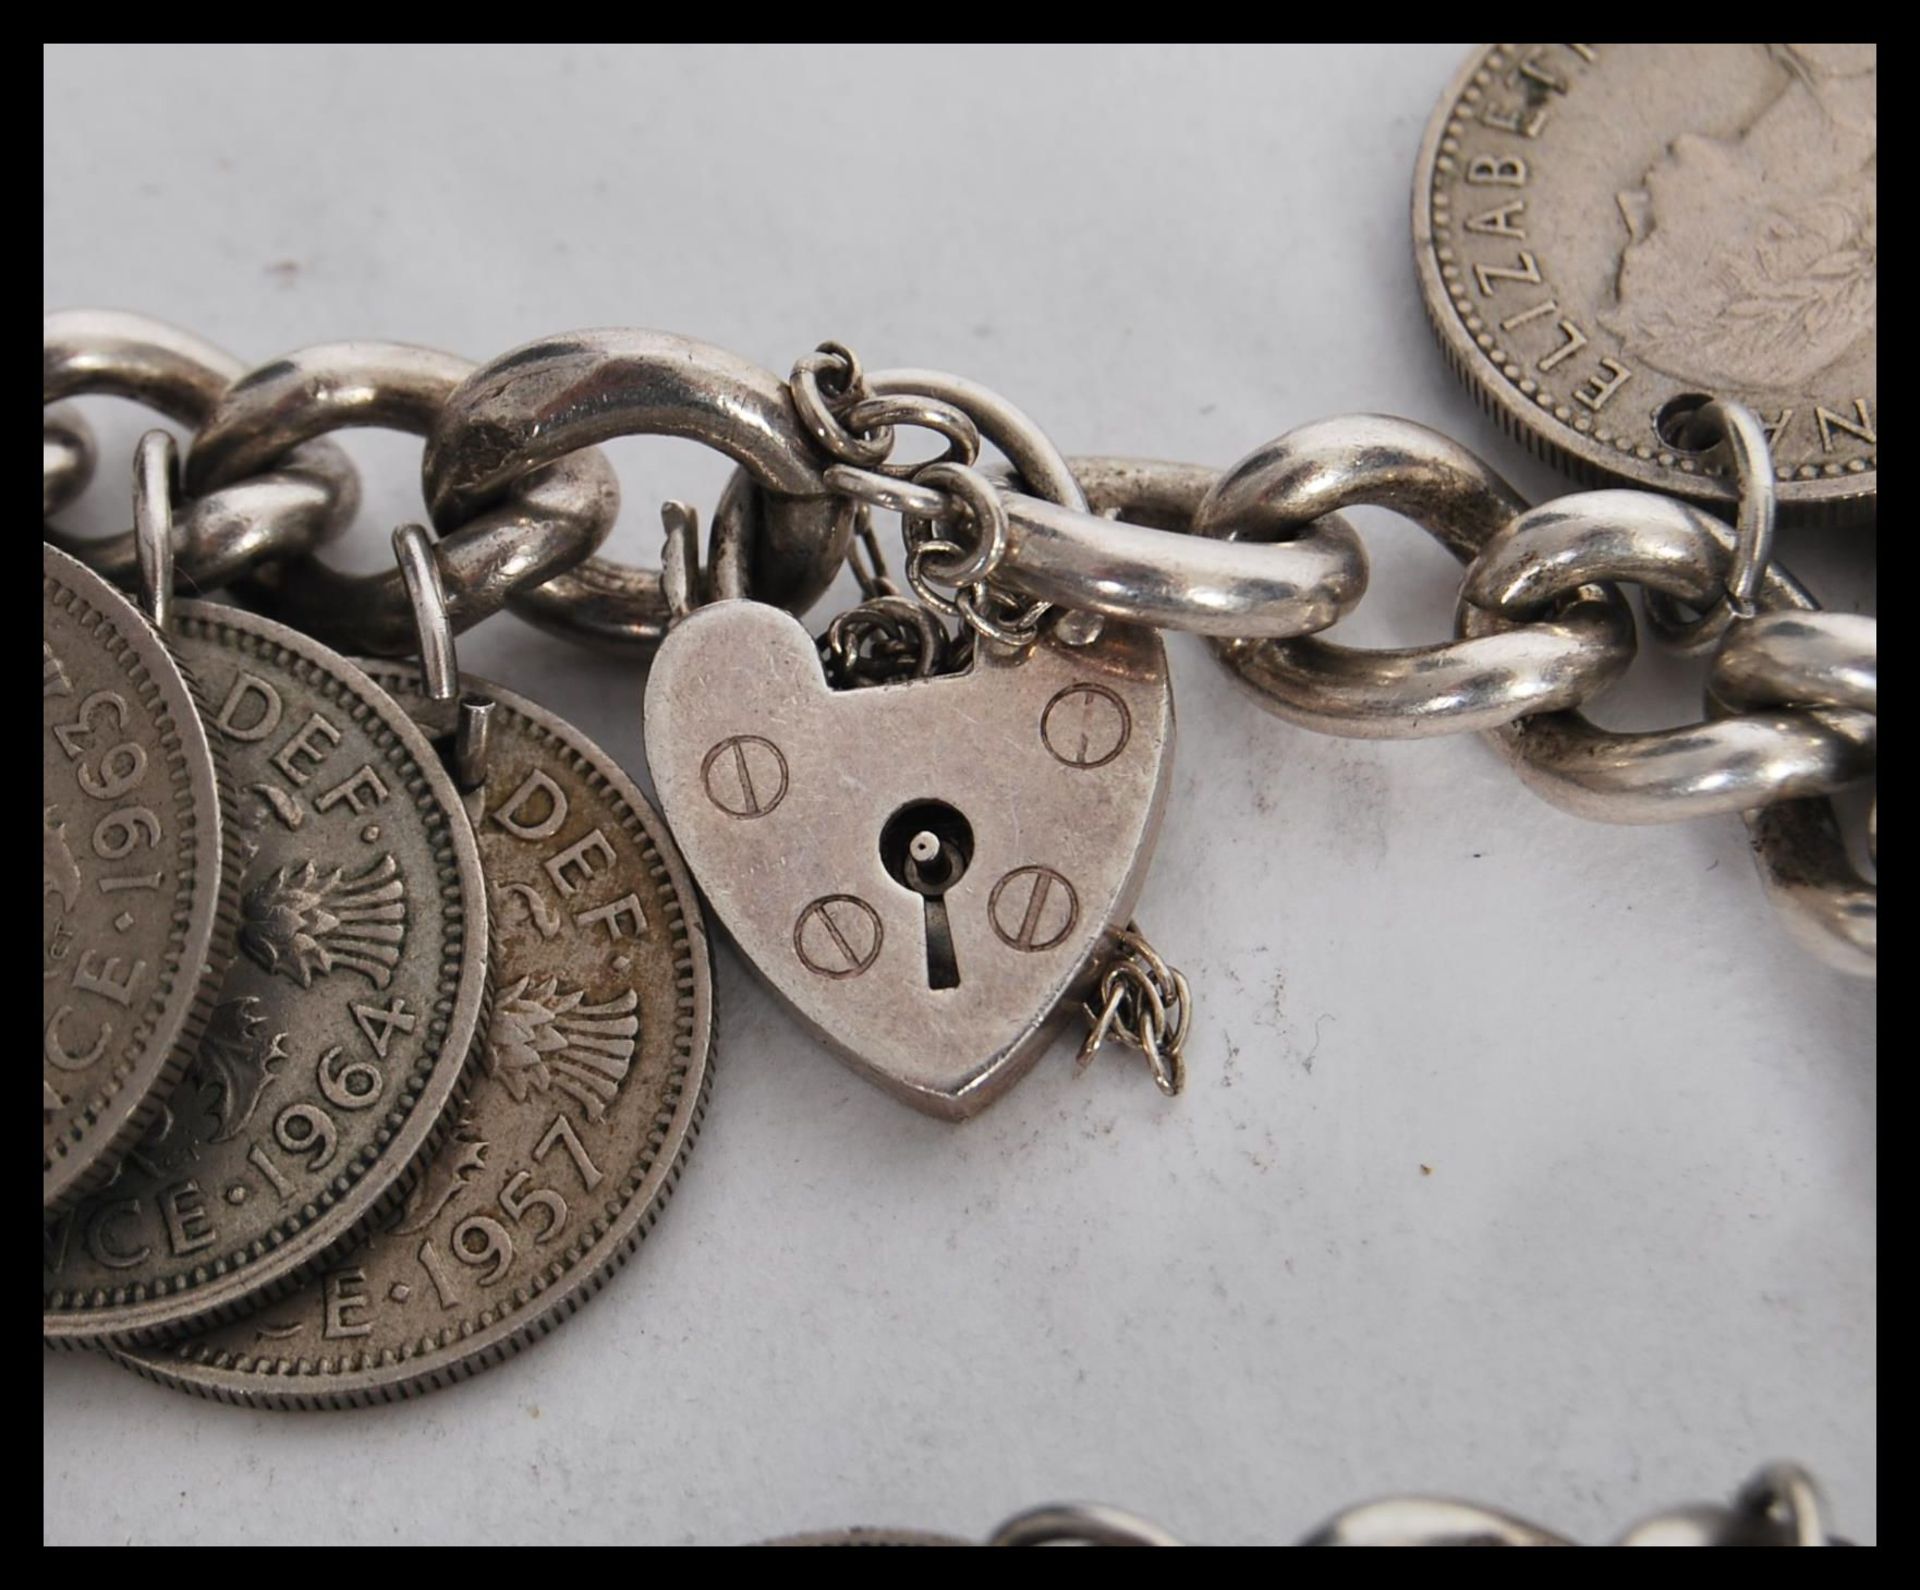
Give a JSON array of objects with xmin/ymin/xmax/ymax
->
[{"xmin": 647, "ymin": 601, "xmax": 1173, "ymax": 1120}]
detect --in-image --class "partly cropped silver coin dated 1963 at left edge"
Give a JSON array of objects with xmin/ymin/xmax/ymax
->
[{"xmin": 40, "ymin": 547, "xmax": 238, "ymax": 1214}]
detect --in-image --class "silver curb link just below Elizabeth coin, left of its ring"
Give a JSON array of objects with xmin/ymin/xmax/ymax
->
[{"xmin": 1459, "ymin": 492, "xmax": 1874, "ymax": 822}]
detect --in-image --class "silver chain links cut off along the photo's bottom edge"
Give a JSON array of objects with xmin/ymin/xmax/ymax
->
[{"xmin": 766, "ymin": 1463, "xmax": 1853, "ymax": 1546}]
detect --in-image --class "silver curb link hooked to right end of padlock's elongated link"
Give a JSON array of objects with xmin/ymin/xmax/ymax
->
[{"xmin": 1194, "ymin": 415, "xmax": 1634, "ymax": 739}]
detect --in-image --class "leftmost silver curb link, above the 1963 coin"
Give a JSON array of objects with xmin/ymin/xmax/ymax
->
[{"xmin": 40, "ymin": 309, "xmax": 359, "ymax": 591}]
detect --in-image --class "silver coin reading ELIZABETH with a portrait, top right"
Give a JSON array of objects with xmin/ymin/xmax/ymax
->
[{"xmin": 1413, "ymin": 44, "xmax": 1878, "ymax": 524}]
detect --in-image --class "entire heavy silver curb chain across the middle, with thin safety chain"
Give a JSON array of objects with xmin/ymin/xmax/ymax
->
[{"xmin": 42, "ymin": 311, "xmax": 1878, "ymax": 983}]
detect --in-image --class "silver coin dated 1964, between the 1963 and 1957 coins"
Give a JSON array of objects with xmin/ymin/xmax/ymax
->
[{"xmin": 42, "ymin": 601, "xmax": 490, "ymax": 1344}]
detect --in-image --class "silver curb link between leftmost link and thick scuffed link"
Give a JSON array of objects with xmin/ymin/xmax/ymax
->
[{"xmin": 186, "ymin": 342, "xmax": 620, "ymax": 657}]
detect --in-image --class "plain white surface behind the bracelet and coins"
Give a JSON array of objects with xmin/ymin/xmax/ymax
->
[{"xmin": 44, "ymin": 44, "xmax": 1876, "ymax": 1542}]
